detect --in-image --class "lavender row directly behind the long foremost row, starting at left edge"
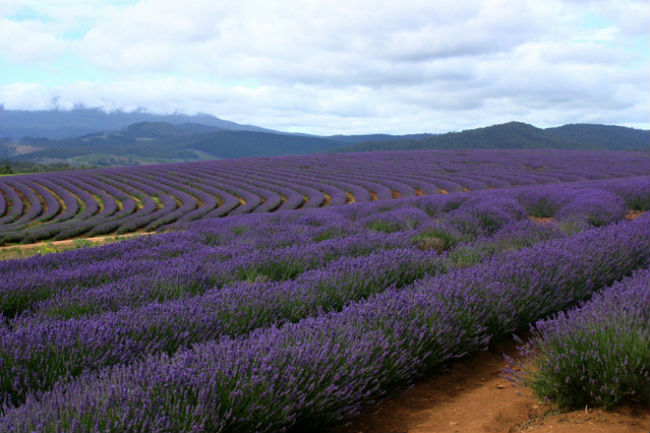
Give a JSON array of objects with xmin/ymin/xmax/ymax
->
[{"xmin": 0, "ymin": 250, "xmax": 444, "ymax": 404}]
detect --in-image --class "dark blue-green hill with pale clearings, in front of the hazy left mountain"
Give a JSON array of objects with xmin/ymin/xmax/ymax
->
[{"xmin": 7, "ymin": 122, "xmax": 341, "ymax": 166}]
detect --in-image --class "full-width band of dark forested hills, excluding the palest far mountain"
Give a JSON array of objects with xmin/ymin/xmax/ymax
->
[{"xmin": 0, "ymin": 114, "xmax": 650, "ymax": 170}]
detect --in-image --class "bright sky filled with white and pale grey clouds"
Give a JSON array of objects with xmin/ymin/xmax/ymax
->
[{"xmin": 0, "ymin": 0, "xmax": 650, "ymax": 135}]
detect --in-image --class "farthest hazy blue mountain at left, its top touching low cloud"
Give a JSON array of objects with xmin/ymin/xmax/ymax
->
[{"xmin": 0, "ymin": 108, "xmax": 274, "ymax": 139}]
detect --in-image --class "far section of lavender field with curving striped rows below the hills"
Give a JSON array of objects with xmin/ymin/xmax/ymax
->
[{"xmin": 0, "ymin": 151, "xmax": 648, "ymax": 243}]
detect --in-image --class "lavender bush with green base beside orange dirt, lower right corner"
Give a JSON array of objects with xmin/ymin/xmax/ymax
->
[{"xmin": 510, "ymin": 269, "xmax": 650, "ymax": 408}]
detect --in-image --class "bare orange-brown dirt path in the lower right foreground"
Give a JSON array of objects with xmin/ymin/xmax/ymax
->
[{"xmin": 332, "ymin": 343, "xmax": 650, "ymax": 433}]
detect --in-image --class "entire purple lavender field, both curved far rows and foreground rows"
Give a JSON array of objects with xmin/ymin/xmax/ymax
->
[{"xmin": 0, "ymin": 151, "xmax": 650, "ymax": 433}]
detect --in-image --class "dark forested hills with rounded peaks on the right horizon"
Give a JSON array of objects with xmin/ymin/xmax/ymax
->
[{"xmin": 334, "ymin": 122, "xmax": 650, "ymax": 152}]
